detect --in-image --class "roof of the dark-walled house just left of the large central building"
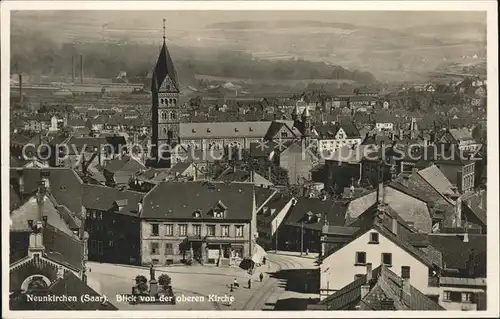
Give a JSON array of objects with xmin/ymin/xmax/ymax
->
[{"xmin": 82, "ymin": 184, "xmax": 144, "ymax": 216}]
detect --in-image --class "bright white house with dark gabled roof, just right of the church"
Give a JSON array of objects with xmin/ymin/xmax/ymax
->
[{"xmin": 314, "ymin": 121, "xmax": 361, "ymax": 153}]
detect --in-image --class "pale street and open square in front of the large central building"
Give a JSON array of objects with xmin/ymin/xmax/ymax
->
[{"xmin": 88, "ymin": 253, "xmax": 313, "ymax": 310}]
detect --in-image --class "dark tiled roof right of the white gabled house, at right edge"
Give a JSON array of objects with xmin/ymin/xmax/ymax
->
[{"xmin": 429, "ymin": 234, "xmax": 487, "ymax": 278}]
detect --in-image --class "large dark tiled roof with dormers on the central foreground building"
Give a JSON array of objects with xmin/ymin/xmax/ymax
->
[{"xmin": 141, "ymin": 182, "xmax": 254, "ymax": 220}]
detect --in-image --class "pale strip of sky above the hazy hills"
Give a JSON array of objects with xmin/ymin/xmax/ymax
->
[{"xmin": 13, "ymin": 11, "xmax": 486, "ymax": 30}]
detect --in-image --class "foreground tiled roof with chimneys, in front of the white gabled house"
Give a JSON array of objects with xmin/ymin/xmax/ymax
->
[{"xmin": 308, "ymin": 263, "xmax": 445, "ymax": 311}]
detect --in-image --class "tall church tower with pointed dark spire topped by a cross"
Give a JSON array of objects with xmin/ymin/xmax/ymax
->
[{"xmin": 151, "ymin": 19, "xmax": 180, "ymax": 167}]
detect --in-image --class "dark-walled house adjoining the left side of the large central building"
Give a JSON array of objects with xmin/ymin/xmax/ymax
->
[{"xmin": 82, "ymin": 184, "xmax": 145, "ymax": 265}]
